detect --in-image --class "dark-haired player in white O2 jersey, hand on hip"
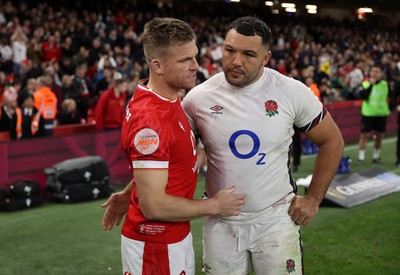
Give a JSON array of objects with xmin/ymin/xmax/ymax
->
[{"xmin": 183, "ymin": 17, "xmax": 344, "ymax": 275}]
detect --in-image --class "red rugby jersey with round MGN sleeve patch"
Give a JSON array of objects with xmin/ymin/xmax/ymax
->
[{"xmin": 121, "ymin": 84, "xmax": 197, "ymax": 243}]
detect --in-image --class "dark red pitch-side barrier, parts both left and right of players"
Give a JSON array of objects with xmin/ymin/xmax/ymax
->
[{"xmin": 0, "ymin": 101, "xmax": 397, "ymax": 191}]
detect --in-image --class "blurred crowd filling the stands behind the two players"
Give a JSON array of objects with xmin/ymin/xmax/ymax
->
[{"xmin": 0, "ymin": 1, "xmax": 400, "ymax": 139}]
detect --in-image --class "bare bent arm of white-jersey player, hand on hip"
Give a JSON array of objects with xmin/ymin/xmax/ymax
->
[{"xmin": 289, "ymin": 113, "xmax": 344, "ymax": 225}]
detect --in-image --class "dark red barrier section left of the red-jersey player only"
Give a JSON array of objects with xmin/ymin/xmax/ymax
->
[{"xmin": 0, "ymin": 128, "xmax": 130, "ymax": 190}]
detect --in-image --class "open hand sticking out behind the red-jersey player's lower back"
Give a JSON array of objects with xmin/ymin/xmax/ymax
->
[{"xmin": 101, "ymin": 179, "xmax": 134, "ymax": 230}]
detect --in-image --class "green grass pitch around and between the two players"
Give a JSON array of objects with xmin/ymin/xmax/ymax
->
[{"xmin": 0, "ymin": 138, "xmax": 400, "ymax": 275}]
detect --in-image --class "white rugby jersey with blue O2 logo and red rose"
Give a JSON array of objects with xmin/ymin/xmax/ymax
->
[{"xmin": 182, "ymin": 68, "xmax": 323, "ymax": 220}]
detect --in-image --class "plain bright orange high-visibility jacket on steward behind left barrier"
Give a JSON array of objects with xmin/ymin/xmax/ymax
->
[{"xmin": 33, "ymin": 87, "xmax": 57, "ymax": 119}]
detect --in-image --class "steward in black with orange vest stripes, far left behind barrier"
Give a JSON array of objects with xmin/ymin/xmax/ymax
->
[{"xmin": 10, "ymin": 92, "xmax": 46, "ymax": 140}]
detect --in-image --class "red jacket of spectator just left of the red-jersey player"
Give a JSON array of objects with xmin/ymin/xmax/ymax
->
[{"xmin": 95, "ymin": 87, "xmax": 126, "ymax": 130}]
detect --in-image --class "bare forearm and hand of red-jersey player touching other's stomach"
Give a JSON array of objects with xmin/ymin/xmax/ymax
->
[{"xmin": 135, "ymin": 169, "xmax": 245, "ymax": 222}]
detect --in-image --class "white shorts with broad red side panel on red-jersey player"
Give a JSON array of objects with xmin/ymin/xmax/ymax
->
[{"xmin": 121, "ymin": 233, "xmax": 195, "ymax": 275}]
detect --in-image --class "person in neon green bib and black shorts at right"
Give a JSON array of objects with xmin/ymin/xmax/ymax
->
[{"xmin": 358, "ymin": 65, "xmax": 390, "ymax": 164}]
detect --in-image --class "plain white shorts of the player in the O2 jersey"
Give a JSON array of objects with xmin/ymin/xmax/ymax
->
[{"xmin": 203, "ymin": 195, "xmax": 303, "ymax": 275}]
